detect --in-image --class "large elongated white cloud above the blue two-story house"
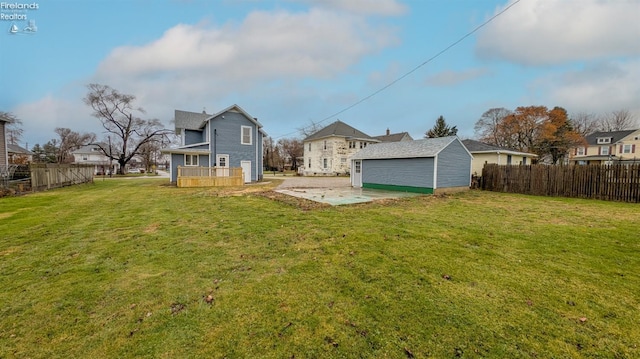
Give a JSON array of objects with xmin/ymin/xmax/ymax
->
[{"xmin": 98, "ymin": 9, "xmax": 397, "ymax": 84}]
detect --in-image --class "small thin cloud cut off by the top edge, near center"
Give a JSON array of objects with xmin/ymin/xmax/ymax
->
[{"xmin": 300, "ymin": 0, "xmax": 407, "ymax": 16}]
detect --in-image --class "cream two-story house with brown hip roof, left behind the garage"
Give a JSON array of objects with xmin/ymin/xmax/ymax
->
[{"xmin": 302, "ymin": 120, "xmax": 380, "ymax": 176}]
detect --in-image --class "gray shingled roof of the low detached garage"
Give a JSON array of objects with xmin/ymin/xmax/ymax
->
[{"xmin": 351, "ymin": 136, "xmax": 464, "ymax": 160}]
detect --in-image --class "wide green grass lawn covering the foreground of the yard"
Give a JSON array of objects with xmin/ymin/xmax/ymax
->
[{"xmin": 0, "ymin": 179, "xmax": 640, "ymax": 358}]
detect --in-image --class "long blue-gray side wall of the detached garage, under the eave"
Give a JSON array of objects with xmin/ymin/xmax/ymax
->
[{"xmin": 362, "ymin": 157, "xmax": 434, "ymax": 188}]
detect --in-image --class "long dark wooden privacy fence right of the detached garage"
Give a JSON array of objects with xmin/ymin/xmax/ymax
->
[{"xmin": 481, "ymin": 163, "xmax": 640, "ymax": 203}]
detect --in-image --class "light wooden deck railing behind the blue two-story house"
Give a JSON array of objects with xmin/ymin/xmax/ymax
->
[{"xmin": 177, "ymin": 166, "xmax": 244, "ymax": 187}]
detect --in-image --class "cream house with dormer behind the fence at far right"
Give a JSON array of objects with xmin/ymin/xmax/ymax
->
[{"xmin": 569, "ymin": 129, "xmax": 640, "ymax": 165}]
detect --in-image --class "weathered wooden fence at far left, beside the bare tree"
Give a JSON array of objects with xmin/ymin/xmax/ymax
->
[{"xmin": 29, "ymin": 163, "xmax": 94, "ymax": 191}]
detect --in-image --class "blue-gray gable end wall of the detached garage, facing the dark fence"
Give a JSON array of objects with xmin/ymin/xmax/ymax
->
[{"xmin": 436, "ymin": 141, "xmax": 471, "ymax": 188}]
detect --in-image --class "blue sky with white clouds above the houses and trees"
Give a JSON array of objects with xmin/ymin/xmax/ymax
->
[{"xmin": 0, "ymin": 0, "xmax": 640, "ymax": 148}]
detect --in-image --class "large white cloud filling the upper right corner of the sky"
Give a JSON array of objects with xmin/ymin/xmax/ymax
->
[{"xmin": 476, "ymin": 0, "xmax": 640, "ymax": 66}]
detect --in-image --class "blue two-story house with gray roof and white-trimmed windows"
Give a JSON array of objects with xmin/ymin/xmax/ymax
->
[{"xmin": 162, "ymin": 105, "xmax": 266, "ymax": 183}]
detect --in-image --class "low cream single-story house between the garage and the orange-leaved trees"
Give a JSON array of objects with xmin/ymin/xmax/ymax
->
[{"xmin": 462, "ymin": 140, "xmax": 538, "ymax": 176}]
